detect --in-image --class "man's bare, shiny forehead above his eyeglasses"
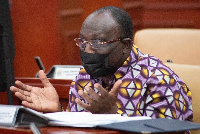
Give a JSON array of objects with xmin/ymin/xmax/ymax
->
[{"xmin": 80, "ymin": 11, "xmax": 119, "ymax": 39}]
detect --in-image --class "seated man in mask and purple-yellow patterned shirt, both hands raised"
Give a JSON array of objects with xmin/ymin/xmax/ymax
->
[{"xmin": 10, "ymin": 6, "xmax": 193, "ymax": 120}]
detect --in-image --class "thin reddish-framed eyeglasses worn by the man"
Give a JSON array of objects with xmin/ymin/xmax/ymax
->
[{"xmin": 74, "ymin": 38, "xmax": 131, "ymax": 50}]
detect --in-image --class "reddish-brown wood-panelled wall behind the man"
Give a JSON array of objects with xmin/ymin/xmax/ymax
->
[{"xmin": 9, "ymin": 0, "xmax": 200, "ymax": 77}]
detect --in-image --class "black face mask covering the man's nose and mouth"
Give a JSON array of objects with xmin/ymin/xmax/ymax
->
[{"xmin": 80, "ymin": 51, "xmax": 117, "ymax": 77}]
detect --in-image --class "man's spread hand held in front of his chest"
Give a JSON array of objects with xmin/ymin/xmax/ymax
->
[{"xmin": 75, "ymin": 80, "xmax": 122, "ymax": 114}]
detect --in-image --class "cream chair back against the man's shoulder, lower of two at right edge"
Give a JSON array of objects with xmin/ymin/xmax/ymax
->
[{"xmin": 166, "ymin": 63, "xmax": 200, "ymax": 134}]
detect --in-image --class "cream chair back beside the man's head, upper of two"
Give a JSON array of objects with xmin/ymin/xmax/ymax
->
[{"xmin": 134, "ymin": 28, "xmax": 200, "ymax": 65}]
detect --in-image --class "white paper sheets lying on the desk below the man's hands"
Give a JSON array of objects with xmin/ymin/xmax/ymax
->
[{"xmin": 44, "ymin": 112, "xmax": 151, "ymax": 127}]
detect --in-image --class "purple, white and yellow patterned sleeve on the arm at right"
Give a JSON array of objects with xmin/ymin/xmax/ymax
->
[{"xmin": 117, "ymin": 65, "xmax": 192, "ymax": 120}]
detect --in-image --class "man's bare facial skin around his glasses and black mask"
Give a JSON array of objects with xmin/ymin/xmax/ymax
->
[{"xmin": 80, "ymin": 12, "xmax": 123, "ymax": 67}]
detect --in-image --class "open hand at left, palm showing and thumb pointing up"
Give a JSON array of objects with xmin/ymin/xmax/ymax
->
[{"xmin": 10, "ymin": 70, "xmax": 61, "ymax": 112}]
